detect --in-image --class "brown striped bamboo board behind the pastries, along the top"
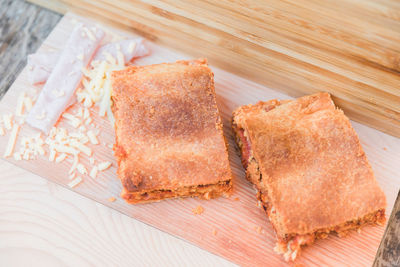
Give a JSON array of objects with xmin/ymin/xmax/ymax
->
[{"xmin": 31, "ymin": 0, "xmax": 400, "ymax": 136}]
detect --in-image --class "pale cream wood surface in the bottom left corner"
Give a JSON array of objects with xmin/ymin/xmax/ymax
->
[{"xmin": 0, "ymin": 161, "xmax": 234, "ymax": 267}]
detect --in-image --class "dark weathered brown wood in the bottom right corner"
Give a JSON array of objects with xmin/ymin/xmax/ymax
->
[{"xmin": 373, "ymin": 191, "xmax": 400, "ymax": 267}]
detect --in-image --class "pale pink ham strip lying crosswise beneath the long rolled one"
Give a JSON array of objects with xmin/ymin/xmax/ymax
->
[{"xmin": 27, "ymin": 38, "xmax": 150, "ymax": 84}]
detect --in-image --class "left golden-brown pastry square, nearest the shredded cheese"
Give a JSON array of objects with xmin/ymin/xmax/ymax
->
[{"xmin": 112, "ymin": 59, "xmax": 232, "ymax": 203}]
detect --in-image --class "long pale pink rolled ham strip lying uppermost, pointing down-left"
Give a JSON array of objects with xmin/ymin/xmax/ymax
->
[{"xmin": 26, "ymin": 24, "xmax": 104, "ymax": 133}]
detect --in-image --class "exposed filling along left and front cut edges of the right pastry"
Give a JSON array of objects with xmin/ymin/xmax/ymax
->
[{"xmin": 233, "ymin": 123, "xmax": 385, "ymax": 261}]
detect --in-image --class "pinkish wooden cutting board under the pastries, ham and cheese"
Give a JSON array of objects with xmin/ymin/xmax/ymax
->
[{"xmin": 0, "ymin": 13, "xmax": 400, "ymax": 266}]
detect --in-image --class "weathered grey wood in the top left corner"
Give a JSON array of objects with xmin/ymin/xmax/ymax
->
[{"xmin": 0, "ymin": 0, "xmax": 61, "ymax": 99}]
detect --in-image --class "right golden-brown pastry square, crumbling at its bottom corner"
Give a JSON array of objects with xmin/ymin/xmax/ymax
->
[{"xmin": 232, "ymin": 93, "xmax": 386, "ymax": 260}]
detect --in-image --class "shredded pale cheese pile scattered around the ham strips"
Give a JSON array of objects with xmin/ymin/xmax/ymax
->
[{"xmin": 0, "ymin": 89, "xmax": 112, "ymax": 187}]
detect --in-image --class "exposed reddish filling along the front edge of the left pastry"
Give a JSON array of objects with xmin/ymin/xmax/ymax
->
[{"xmin": 121, "ymin": 180, "xmax": 232, "ymax": 203}]
